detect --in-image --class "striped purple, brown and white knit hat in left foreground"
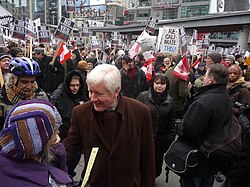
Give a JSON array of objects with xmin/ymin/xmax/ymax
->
[{"xmin": 0, "ymin": 99, "xmax": 62, "ymax": 160}]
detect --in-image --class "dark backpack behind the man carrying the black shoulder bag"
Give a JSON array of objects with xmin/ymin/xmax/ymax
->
[{"xmin": 200, "ymin": 114, "xmax": 241, "ymax": 160}]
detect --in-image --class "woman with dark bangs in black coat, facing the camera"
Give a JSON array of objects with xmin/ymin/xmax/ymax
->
[{"xmin": 137, "ymin": 73, "xmax": 176, "ymax": 178}]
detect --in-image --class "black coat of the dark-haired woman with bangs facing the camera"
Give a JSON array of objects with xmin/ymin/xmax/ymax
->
[{"xmin": 137, "ymin": 88, "xmax": 176, "ymax": 177}]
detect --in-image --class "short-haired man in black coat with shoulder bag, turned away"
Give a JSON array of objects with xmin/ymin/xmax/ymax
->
[{"xmin": 177, "ymin": 63, "xmax": 232, "ymax": 187}]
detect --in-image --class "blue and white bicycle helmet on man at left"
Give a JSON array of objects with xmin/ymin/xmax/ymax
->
[{"xmin": 9, "ymin": 57, "xmax": 40, "ymax": 76}]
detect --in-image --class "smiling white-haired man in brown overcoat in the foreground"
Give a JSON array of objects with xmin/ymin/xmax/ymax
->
[{"xmin": 63, "ymin": 64, "xmax": 155, "ymax": 187}]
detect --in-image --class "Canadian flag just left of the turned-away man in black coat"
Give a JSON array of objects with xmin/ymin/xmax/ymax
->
[{"xmin": 173, "ymin": 55, "xmax": 190, "ymax": 81}]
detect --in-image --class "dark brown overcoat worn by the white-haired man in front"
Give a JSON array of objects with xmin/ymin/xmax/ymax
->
[{"xmin": 63, "ymin": 96, "xmax": 155, "ymax": 187}]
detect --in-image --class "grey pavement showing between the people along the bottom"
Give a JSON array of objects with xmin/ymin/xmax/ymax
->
[{"xmin": 74, "ymin": 154, "xmax": 221, "ymax": 187}]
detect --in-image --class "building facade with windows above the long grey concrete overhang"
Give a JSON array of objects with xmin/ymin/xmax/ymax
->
[{"xmin": 125, "ymin": 0, "xmax": 210, "ymax": 24}]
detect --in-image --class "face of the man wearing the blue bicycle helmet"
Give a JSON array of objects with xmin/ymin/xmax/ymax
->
[{"xmin": 17, "ymin": 76, "xmax": 37, "ymax": 98}]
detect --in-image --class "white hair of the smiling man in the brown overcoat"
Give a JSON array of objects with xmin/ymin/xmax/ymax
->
[{"xmin": 86, "ymin": 64, "xmax": 121, "ymax": 93}]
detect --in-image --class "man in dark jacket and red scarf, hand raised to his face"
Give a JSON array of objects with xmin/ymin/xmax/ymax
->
[{"xmin": 120, "ymin": 55, "xmax": 149, "ymax": 99}]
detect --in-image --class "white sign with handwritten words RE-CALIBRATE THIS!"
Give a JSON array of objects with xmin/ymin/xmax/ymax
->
[{"xmin": 157, "ymin": 27, "xmax": 180, "ymax": 54}]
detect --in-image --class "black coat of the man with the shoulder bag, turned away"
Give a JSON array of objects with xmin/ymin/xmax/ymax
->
[{"xmin": 177, "ymin": 84, "xmax": 232, "ymax": 177}]
